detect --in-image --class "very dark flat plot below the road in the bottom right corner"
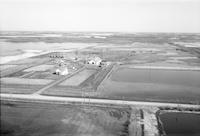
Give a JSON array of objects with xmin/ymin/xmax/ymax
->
[{"xmin": 159, "ymin": 112, "xmax": 200, "ymax": 136}]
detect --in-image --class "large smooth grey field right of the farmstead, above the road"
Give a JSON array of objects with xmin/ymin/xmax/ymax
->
[{"xmin": 98, "ymin": 67, "xmax": 200, "ymax": 103}]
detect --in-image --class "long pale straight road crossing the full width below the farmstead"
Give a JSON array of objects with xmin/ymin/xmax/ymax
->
[{"xmin": 0, "ymin": 93, "xmax": 200, "ymax": 109}]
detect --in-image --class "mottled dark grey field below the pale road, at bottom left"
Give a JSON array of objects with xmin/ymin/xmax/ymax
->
[{"xmin": 1, "ymin": 100, "xmax": 130, "ymax": 136}]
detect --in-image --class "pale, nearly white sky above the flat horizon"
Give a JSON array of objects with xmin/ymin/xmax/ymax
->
[{"xmin": 0, "ymin": 0, "xmax": 200, "ymax": 33}]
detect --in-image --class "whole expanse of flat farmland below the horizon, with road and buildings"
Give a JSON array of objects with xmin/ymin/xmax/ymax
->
[{"xmin": 0, "ymin": 32, "xmax": 200, "ymax": 136}]
